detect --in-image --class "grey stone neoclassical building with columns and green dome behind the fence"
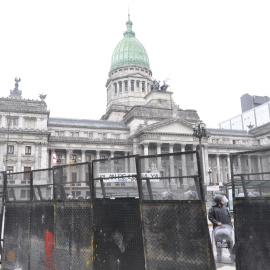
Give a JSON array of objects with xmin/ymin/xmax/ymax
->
[{"xmin": 0, "ymin": 17, "xmax": 270, "ymax": 191}]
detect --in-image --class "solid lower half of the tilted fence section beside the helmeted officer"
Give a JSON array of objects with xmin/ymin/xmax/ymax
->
[{"xmin": 142, "ymin": 201, "xmax": 212, "ymax": 270}]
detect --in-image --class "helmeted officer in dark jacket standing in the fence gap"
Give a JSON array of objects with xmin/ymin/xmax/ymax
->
[{"xmin": 208, "ymin": 194, "xmax": 233, "ymax": 261}]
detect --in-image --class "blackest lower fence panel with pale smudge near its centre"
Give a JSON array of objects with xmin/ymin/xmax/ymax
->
[{"xmin": 94, "ymin": 198, "xmax": 145, "ymax": 270}]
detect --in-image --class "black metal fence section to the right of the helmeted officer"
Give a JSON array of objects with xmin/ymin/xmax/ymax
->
[{"xmin": 230, "ymin": 148, "xmax": 270, "ymax": 270}]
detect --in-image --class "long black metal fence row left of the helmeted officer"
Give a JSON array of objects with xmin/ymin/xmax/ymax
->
[{"xmin": 0, "ymin": 151, "xmax": 215, "ymax": 270}]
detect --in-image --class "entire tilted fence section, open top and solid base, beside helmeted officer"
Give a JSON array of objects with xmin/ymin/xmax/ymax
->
[{"xmin": 137, "ymin": 151, "xmax": 215, "ymax": 270}]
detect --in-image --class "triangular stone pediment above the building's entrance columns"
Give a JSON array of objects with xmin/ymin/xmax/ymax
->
[{"xmin": 145, "ymin": 119, "xmax": 193, "ymax": 134}]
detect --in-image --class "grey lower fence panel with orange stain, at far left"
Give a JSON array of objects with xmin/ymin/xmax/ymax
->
[{"xmin": 2, "ymin": 202, "xmax": 30, "ymax": 270}]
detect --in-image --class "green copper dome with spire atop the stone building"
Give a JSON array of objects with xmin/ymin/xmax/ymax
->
[{"xmin": 111, "ymin": 15, "xmax": 150, "ymax": 70}]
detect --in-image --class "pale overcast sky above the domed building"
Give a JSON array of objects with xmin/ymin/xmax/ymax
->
[{"xmin": 0, "ymin": 0, "xmax": 270, "ymax": 128}]
